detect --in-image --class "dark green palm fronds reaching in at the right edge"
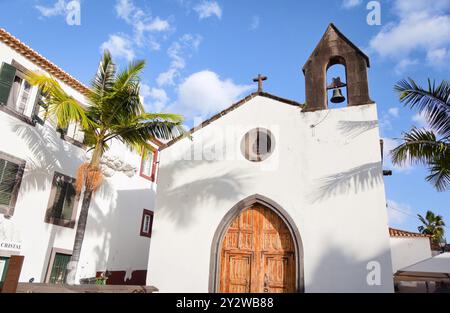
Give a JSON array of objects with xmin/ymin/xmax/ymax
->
[{"xmin": 391, "ymin": 78, "xmax": 450, "ymax": 191}]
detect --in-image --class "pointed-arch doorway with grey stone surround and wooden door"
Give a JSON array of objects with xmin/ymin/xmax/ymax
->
[{"xmin": 209, "ymin": 195, "xmax": 303, "ymax": 292}]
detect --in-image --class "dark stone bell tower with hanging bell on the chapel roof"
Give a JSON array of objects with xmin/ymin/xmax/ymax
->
[{"xmin": 303, "ymin": 24, "xmax": 373, "ymax": 111}]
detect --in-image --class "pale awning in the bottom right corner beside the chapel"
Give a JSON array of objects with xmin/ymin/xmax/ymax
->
[{"xmin": 394, "ymin": 252, "xmax": 450, "ymax": 283}]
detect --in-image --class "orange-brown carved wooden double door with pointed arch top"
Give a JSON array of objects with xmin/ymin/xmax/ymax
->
[{"xmin": 219, "ymin": 204, "xmax": 296, "ymax": 293}]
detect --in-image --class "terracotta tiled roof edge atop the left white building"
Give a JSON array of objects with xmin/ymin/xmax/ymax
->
[{"xmin": 0, "ymin": 28, "xmax": 89, "ymax": 95}]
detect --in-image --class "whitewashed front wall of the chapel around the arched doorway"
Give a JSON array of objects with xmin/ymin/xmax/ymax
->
[{"xmin": 147, "ymin": 96, "xmax": 393, "ymax": 292}]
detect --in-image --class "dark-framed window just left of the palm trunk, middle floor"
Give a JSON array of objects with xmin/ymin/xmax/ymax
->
[{"xmin": 45, "ymin": 173, "xmax": 78, "ymax": 228}]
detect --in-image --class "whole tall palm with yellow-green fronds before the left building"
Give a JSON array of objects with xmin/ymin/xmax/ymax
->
[{"xmin": 27, "ymin": 51, "xmax": 185, "ymax": 283}]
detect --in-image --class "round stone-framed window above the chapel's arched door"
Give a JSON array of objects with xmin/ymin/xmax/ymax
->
[{"xmin": 241, "ymin": 128, "xmax": 275, "ymax": 162}]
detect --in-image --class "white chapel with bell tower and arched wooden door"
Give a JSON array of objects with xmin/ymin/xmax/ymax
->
[{"xmin": 147, "ymin": 25, "xmax": 393, "ymax": 292}]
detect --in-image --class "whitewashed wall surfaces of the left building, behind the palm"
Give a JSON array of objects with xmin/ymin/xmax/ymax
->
[{"xmin": 0, "ymin": 43, "xmax": 156, "ymax": 282}]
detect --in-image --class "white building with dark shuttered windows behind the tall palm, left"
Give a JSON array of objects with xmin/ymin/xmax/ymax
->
[{"xmin": 0, "ymin": 29, "xmax": 157, "ymax": 284}]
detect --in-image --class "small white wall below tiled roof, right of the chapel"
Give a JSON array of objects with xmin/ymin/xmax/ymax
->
[{"xmin": 390, "ymin": 237, "xmax": 432, "ymax": 273}]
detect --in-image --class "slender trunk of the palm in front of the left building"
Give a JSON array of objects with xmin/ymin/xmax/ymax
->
[{"xmin": 66, "ymin": 143, "xmax": 103, "ymax": 285}]
